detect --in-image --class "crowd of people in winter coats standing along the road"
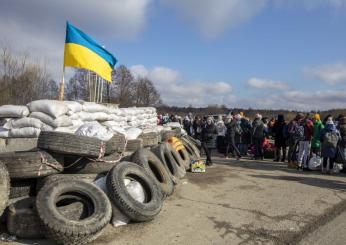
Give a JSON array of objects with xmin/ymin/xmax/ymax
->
[{"xmin": 159, "ymin": 112, "xmax": 346, "ymax": 173}]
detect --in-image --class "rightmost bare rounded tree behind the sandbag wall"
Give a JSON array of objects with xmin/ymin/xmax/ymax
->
[{"xmin": 134, "ymin": 78, "xmax": 162, "ymax": 106}]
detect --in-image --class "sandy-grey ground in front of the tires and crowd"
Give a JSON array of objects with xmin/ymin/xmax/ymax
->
[{"xmin": 7, "ymin": 155, "xmax": 346, "ymax": 245}]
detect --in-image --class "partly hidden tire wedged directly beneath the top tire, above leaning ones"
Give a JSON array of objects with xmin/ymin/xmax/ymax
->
[{"xmin": 64, "ymin": 153, "xmax": 121, "ymax": 174}]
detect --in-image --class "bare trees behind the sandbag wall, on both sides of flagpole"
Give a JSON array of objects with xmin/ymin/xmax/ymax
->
[{"xmin": 0, "ymin": 47, "xmax": 162, "ymax": 107}]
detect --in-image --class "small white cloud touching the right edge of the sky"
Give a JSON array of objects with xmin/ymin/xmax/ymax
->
[{"xmin": 304, "ymin": 62, "xmax": 346, "ymax": 85}]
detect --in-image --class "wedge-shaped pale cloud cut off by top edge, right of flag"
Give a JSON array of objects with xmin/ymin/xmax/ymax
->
[{"xmin": 161, "ymin": 0, "xmax": 268, "ymax": 38}]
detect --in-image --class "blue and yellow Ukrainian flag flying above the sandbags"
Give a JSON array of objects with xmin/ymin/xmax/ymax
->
[{"xmin": 64, "ymin": 22, "xmax": 117, "ymax": 83}]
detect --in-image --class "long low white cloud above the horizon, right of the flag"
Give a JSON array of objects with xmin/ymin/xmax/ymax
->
[{"xmin": 130, "ymin": 65, "xmax": 235, "ymax": 106}]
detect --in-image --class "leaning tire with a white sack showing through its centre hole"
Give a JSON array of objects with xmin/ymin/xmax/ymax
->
[{"xmin": 107, "ymin": 162, "xmax": 162, "ymax": 222}]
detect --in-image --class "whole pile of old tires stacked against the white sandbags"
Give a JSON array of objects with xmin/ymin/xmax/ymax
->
[{"xmin": 0, "ymin": 132, "xmax": 199, "ymax": 244}]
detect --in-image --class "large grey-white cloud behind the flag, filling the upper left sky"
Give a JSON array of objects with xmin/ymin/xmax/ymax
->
[{"xmin": 0, "ymin": 0, "xmax": 153, "ymax": 79}]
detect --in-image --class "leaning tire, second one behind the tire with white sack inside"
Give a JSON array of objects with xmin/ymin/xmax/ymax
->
[{"xmin": 152, "ymin": 143, "xmax": 182, "ymax": 184}]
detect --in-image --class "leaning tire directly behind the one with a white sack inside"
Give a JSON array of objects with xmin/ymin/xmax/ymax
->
[{"xmin": 131, "ymin": 148, "xmax": 174, "ymax": 196}]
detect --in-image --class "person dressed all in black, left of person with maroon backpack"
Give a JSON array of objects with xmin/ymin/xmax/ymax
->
[{"xmin": 272, "ymin": 115, "xmax": 287, "ymax": 162}]
